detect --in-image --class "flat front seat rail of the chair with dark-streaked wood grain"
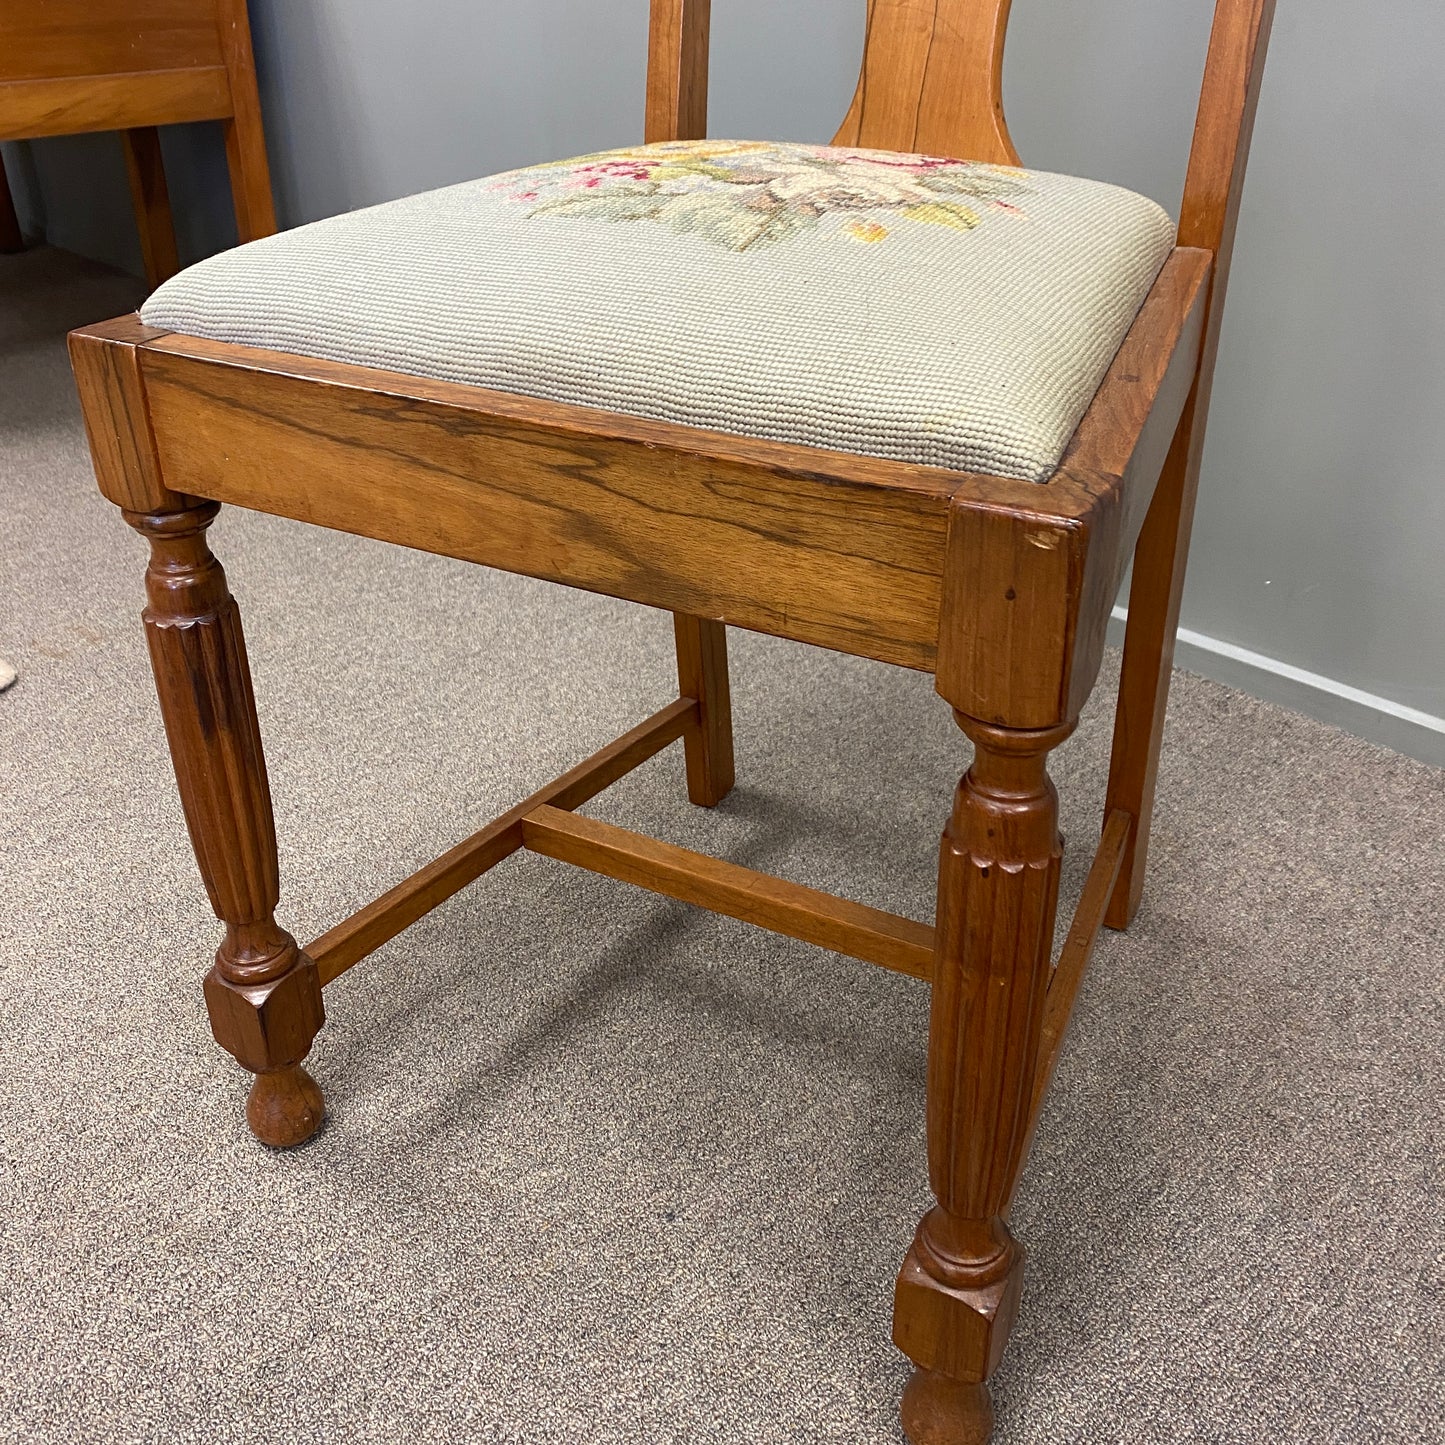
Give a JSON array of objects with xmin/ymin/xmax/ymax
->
[{"xmin": 140, "ymin": 337, "xmax": 958, "ymax": 668}]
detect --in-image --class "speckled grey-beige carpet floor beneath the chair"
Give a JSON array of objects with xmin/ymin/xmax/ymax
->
[{"xmin": 0, "ymin": 242, "xmax": 1445, "ymax": 1445}]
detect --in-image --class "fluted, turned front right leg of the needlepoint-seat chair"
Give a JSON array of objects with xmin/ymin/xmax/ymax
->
[{"xmin": 893, "ymin": 715, "xmax": 1072, "ymax": 1445}]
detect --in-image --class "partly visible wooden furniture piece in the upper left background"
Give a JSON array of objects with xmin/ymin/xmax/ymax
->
[{"xmin": 0, "ymin": 0, "xmax": 276, "ymax": 286}]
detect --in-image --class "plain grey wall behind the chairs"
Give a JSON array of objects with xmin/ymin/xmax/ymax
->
[{"xmin": 7, "ymin": 0, "xmax": 1445, "ymax": 760}]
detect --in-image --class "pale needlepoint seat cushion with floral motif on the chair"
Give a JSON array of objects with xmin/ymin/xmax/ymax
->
[{"xmin": 142, "ymin": 140, "xmax": 1173, "ymax": 481}]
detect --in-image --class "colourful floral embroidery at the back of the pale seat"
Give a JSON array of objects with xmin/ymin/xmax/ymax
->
[{"xmin": 494, "ymin": 140, "xmax": 1029, "ymax": 251}]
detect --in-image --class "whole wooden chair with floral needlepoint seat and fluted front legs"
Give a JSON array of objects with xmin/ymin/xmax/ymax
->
[{"xmin": 72, "ymin": 0, "xmax": 1273, "ymax": 1445}]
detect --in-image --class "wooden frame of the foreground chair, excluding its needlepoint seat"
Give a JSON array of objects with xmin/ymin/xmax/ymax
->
[{"xmin": 72, "ymin": 0, "xmax": 1273, "ymax": 1445}]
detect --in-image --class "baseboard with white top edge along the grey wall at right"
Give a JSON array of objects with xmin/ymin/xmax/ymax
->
[{"xmin": 1108, "ymin": 607, "xmax": 1445, "ymax": 767}]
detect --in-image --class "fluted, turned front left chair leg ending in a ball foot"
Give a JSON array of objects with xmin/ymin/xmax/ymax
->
[{"xmin": 126, "ymin": 501, "xmax": 325, "ymax": 1149}]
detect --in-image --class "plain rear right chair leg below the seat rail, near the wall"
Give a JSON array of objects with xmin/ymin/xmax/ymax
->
[{"xmin": 1104, "ymin": 396, "xmax": 1199, "ymax": 928}]
